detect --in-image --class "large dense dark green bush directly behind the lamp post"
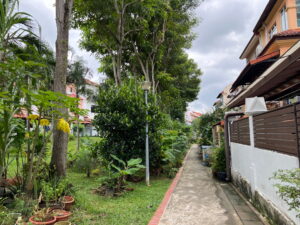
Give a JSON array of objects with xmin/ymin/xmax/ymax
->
[{"xmin": 94, "ymin": 80, "xmax": 162, "ymax": 169}]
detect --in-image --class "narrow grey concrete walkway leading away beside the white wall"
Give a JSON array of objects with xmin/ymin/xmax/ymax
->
[{"xmin": 159, "ymin": 145, "xmax": 262, "ymax": 225}]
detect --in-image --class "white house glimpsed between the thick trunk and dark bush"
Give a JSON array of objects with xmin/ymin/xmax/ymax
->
[{"xmin": 66, "ymin": 79, "xmax": 99, "ymax": 136}]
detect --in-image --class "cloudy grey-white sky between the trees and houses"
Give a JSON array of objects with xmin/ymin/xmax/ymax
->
[{"xmin": 20, "ymin": 0, "xmax": 268, "ymax": 112}]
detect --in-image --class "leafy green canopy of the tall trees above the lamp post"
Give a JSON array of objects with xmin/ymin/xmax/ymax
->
[{"xmin": 73, "ymin": 0, "xmax": 201, "ymax": 120}]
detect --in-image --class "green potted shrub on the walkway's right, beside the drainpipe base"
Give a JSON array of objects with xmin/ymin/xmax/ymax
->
[{"xmin": 212, "ymin": 145, "xmax": 226, "ymax": 181}]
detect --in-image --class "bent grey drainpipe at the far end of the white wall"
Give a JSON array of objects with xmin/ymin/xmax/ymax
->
[{"xmin": 224, "ymin": 112, "xmax": 244, "ymax": 181}]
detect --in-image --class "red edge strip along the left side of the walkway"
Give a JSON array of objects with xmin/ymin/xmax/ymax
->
[{"xmin": 148, "ymin": 145, "xmax": 192, "ymax": 225}]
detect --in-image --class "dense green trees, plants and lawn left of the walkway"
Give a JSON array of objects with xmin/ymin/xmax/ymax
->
[{"xmin": 0, "ymin": 0, "xmax": 201, "ymax": 225}]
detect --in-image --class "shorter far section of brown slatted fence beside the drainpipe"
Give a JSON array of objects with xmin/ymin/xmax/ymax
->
[{"xmin": 230, "ymin": 118, "xmax": 250, "ymax": 145}]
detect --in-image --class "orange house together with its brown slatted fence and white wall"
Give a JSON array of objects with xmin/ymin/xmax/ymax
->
[{"xmin": 224, "ymin": 0, "xmax": 300, "ymax": 225}]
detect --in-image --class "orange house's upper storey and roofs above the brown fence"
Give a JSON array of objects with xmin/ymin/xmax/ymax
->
[{"xmin": 228, "ymin": 0, "xmax": 300, "ymax": 108}]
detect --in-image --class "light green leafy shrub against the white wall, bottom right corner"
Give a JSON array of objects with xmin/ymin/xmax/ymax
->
[{"xmin": 271, "ymin": 168, "xmax": 300, "ymax": 218}]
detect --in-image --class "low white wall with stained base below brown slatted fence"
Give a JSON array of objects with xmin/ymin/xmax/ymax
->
[{"xmin": 231, "ymin": 142, "xmax": 300, "ymax": 225}]
